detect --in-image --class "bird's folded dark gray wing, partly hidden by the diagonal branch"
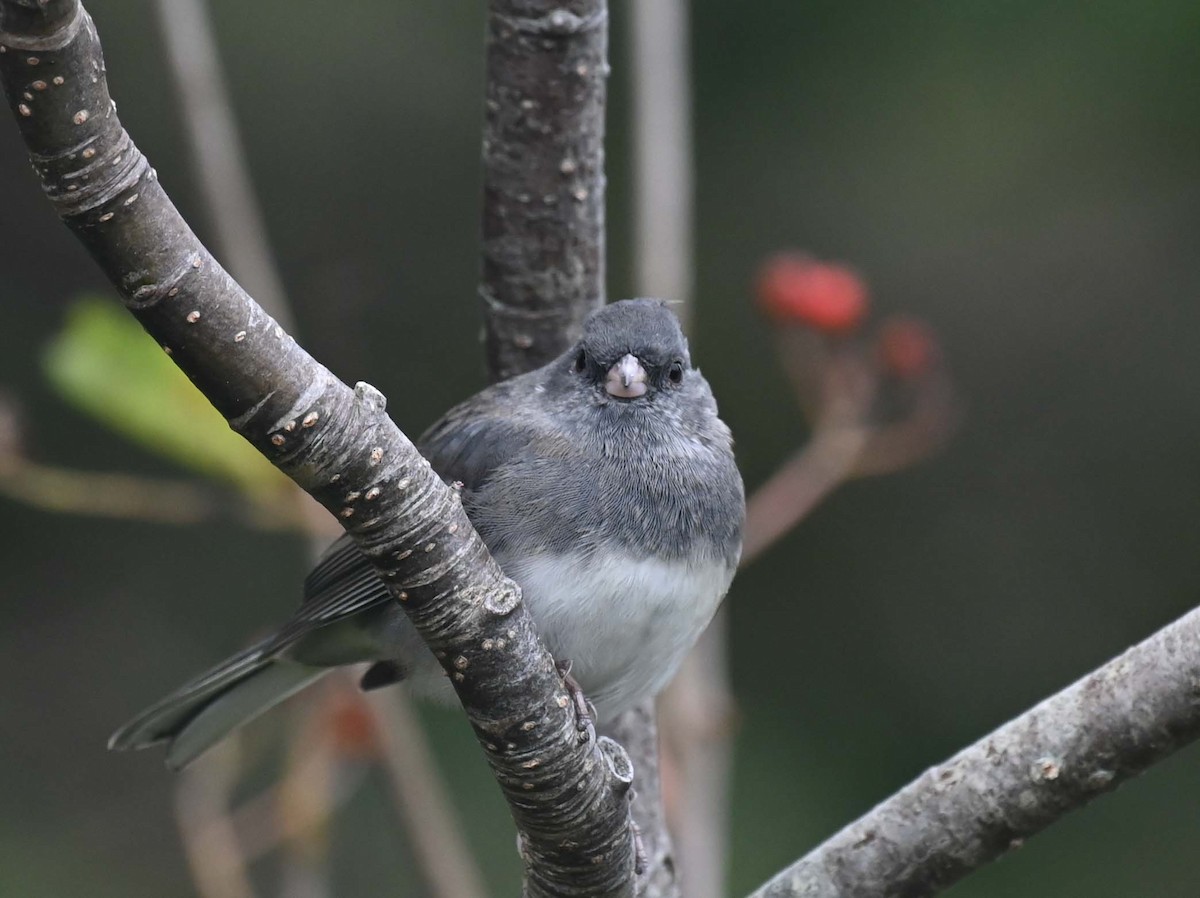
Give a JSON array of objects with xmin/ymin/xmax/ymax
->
[{"xmin": 277, "ymin": 378, "xmax": 544, "ymax": 647}]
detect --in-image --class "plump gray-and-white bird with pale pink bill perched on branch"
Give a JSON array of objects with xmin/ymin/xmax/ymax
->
[{"xmin": 109, "ymin": 299, "xmax": 745, "ymax": 770}]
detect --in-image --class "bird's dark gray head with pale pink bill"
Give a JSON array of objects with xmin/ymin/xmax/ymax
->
[{"xmin": 570, "ymin": 299, "xmax": 692, "ymax": 402}]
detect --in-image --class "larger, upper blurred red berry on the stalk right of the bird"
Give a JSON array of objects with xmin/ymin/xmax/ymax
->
[{"xmin": 758, "ymin": 253, "xmax": 866, "ymax": 334}]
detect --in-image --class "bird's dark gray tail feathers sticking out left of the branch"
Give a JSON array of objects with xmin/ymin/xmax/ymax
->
[{"xmin": 108, "ymin": 645, "xmax": 330, "ymax": 770}]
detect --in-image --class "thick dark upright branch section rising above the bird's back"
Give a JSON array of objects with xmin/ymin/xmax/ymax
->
[{"xmin": 479, "ymin": 0, "xmax": 608, "ymax": 381}]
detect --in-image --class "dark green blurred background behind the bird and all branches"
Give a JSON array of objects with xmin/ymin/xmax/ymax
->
[{"xmin": 0, "ymin": 0, "xmax": 1200, "ymax": 898}]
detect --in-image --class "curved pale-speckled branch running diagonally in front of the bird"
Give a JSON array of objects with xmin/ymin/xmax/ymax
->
[{"xmin": 0, "ymin": 0, "xmax": 632, "ymax": 896}]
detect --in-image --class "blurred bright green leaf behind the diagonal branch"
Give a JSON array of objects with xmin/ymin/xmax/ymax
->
[{"xmin": 43, "ymin": 295, "xmax": 294, "ymax": 497}]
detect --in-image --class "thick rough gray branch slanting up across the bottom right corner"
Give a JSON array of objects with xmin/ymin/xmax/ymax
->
[{"xmin": 752, "ymin": 610, "xmax": 1200, "ymax": 898}]
